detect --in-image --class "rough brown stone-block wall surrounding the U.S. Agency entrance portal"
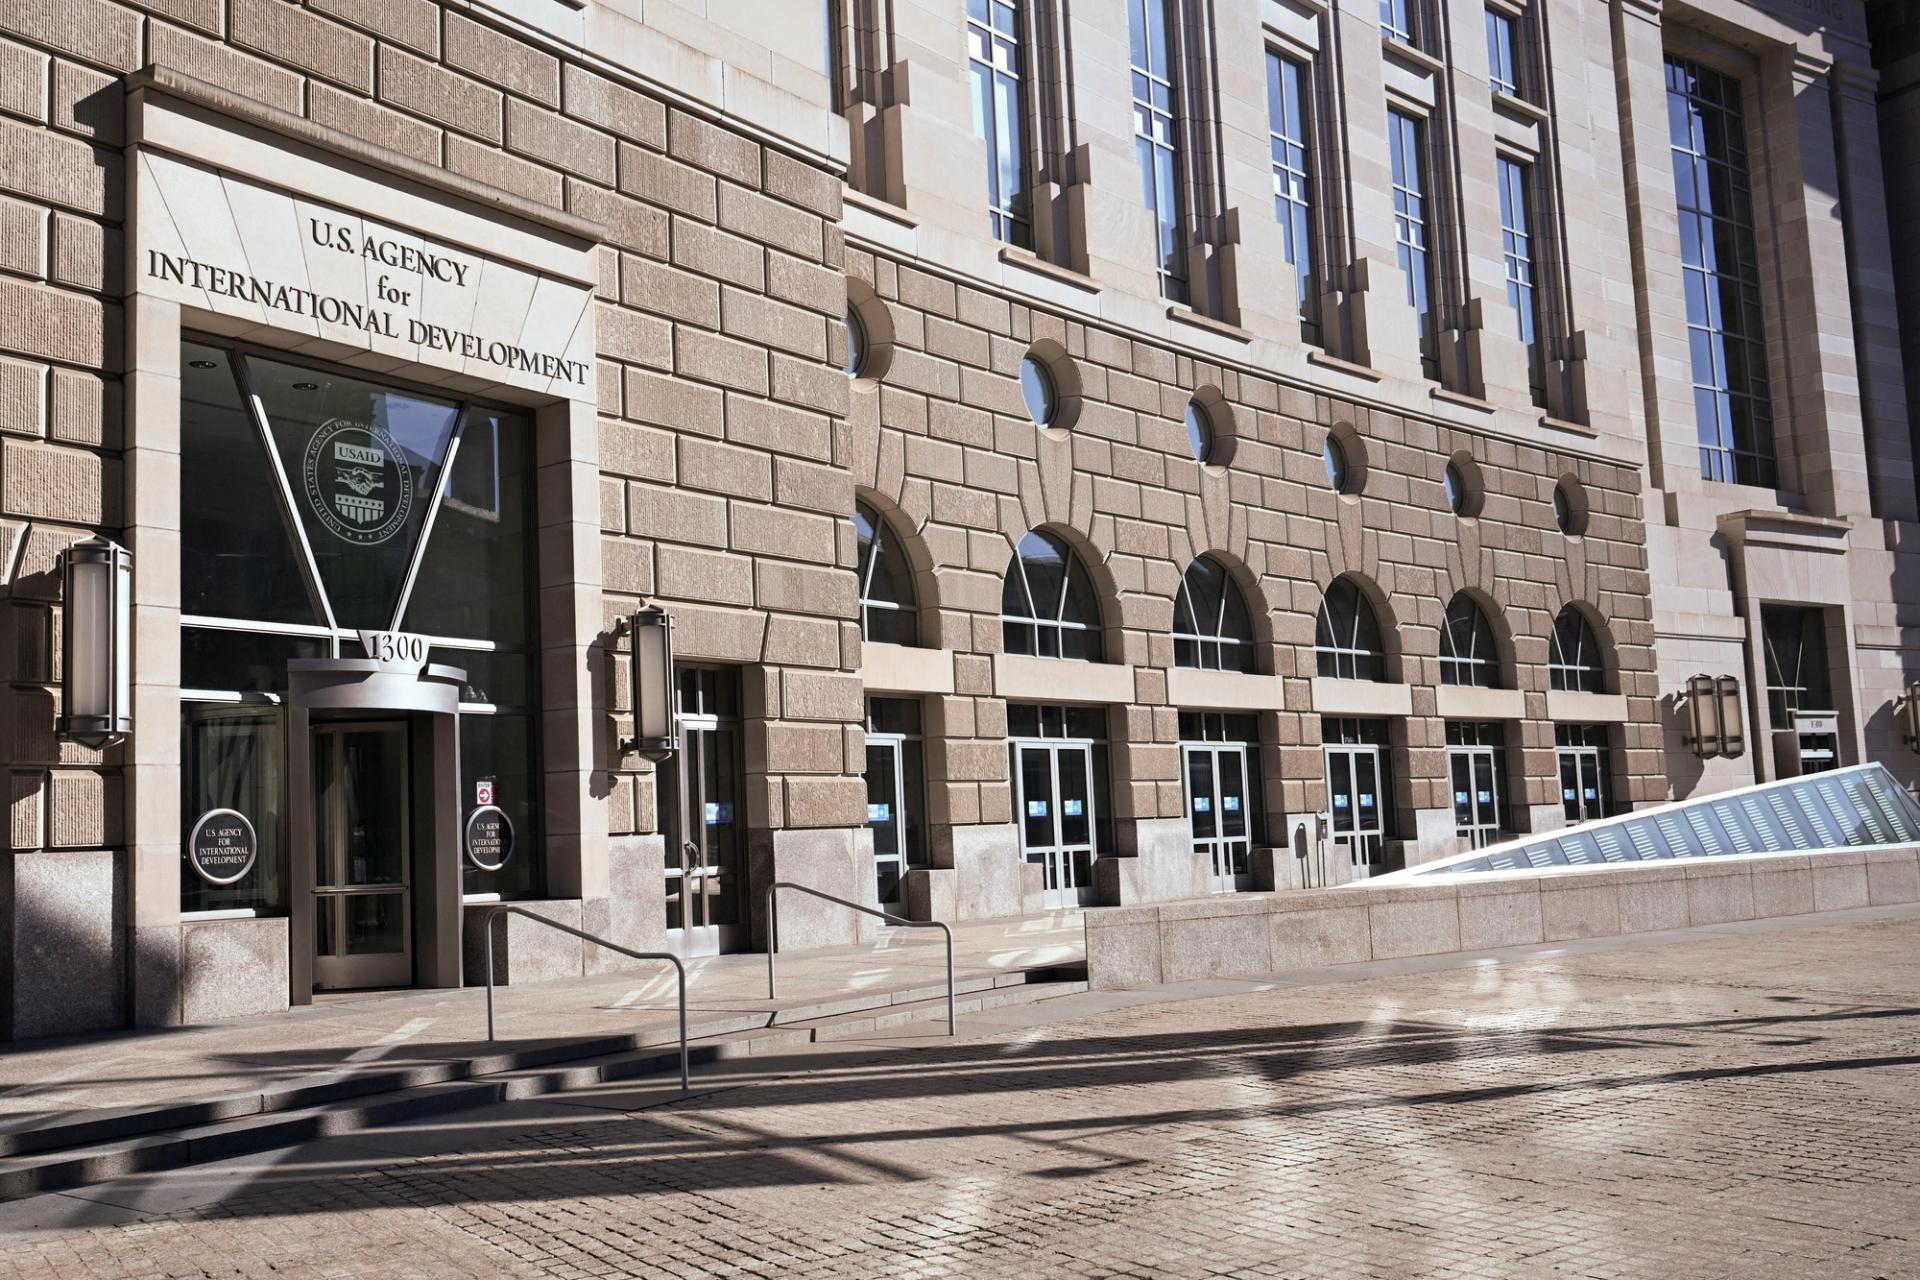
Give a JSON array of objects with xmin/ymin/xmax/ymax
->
[{"xmin": 0, "ymin": 0, "xmax": 864, "ymax": 848}]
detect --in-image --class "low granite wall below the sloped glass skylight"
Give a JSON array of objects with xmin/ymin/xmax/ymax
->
[{"xmin": 1087, "ymin": 848, "xmax": 1920, "ymax": 990}]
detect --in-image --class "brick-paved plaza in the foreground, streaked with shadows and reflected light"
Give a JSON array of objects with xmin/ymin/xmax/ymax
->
[{"xmin": 0, "ymin": 908, "xmax": 1920, "ymax": 1280}]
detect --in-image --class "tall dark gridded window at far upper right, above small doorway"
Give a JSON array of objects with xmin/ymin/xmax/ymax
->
[{"xmin": 1667, "ymin": 58, "xmax": 1778, "ymax": 487}]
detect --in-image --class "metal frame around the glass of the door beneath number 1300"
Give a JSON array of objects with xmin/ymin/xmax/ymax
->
[{"xmin": 307, "ymin": 720, "xmax": 413, "ymax": 990}]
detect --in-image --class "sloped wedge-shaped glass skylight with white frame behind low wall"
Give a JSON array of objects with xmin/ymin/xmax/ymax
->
[{"xmin": 1369, "ymin": 764, "xmax": 1920, "ymax": 885}]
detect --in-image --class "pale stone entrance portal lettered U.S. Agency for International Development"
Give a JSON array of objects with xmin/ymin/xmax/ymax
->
[{"xmin": 127, "ymin": 69, "xmax": 607, "ymax": 1023}]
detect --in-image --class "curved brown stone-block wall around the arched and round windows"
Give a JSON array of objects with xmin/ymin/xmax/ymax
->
[{"xmin": 847, "ymin": 239, "xmax": 1665, "ymax": 837}]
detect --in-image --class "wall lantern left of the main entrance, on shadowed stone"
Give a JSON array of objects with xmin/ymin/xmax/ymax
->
[{"xmin": 58, "ymin": 537, "xmax": 132, "ymax": 747}]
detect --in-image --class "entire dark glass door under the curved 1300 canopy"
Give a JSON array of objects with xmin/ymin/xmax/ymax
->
[{"xmin": 313, "ymin": 722, "xmax": 413, "ymax": 990}]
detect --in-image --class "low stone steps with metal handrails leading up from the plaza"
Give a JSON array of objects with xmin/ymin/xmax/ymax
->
[{"xmin": 0, "ymin": 961, "xmax": 1087, "ymax": 1199}]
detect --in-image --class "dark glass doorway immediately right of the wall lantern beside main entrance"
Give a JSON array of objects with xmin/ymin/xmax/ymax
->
[{"xmin": 659, "ymin": 668, "xmax": 747, "ymax": 956}]
